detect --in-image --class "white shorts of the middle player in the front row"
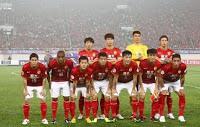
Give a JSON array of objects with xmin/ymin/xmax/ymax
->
[{"xmin": 94, "ymin": 80, "xmax": 110, "ymax": 96}]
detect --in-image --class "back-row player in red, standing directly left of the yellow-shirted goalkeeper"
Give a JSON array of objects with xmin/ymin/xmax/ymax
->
[{"xmin": 99, "ymin": 33, "xmax": 124, "ymax": 119}]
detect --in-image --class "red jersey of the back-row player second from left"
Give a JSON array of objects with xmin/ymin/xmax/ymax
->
[{"xmin": 100, "ymin": 47, "xmax": 121, "ymax": 60}]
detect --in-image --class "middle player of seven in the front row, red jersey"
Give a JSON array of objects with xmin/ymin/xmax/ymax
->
[{"xmin": 90, "ymin": 52, "xmax": 113, "ymax": 122}]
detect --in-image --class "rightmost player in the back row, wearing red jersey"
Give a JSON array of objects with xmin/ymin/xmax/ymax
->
[{"xmin": 157, "ymin": 35, "xmax": 175, "ymax": 119}]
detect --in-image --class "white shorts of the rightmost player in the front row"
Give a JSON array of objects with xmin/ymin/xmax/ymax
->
[{"xmin": 162, "ymin": 80, "xmax": 181, "ymax": 92}]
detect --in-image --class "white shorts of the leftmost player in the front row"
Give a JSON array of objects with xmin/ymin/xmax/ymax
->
[{"xmin": 25, "ymin": 86, "xmax": 45, "ymax": 99}]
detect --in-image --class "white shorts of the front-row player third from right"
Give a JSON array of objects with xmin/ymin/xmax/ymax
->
[{"xmin": 114, "ymin": 80, "xmax": 133, "ymax": 96}]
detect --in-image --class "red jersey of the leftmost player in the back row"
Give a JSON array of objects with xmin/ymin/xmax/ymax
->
[{"xmin": 79, "ymin": 49, "xmax": 99, "ymax": 60}]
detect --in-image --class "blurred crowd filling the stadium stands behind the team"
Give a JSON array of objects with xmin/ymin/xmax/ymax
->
[{"xmin": 0, "ymin": 0, "xmax": 200, "ymax": 49}]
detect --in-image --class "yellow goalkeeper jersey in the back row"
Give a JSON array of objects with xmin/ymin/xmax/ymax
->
[{"xmin": 126, "ymin": 44, "xmax": 148, "ymax": 64}]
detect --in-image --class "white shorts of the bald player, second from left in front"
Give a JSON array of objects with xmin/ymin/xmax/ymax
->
[{"xmin": 51, "ymin": 81, "xmax": 70, "ymax": 98}]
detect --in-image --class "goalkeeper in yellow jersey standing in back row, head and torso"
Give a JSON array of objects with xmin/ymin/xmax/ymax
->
[{"xmin": 126, "ymin": 31, "xmax": 148, "ymax": 64}]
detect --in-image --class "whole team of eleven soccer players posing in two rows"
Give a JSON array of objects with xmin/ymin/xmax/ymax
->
[{"xmin": 21, "ymin": 31, "xmax": 186, "ymax": 125}]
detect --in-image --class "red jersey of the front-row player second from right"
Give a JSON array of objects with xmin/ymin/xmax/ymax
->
[{"xmin": 139, "ymin": 59, "xmax": 161, "ymax": 84}]
